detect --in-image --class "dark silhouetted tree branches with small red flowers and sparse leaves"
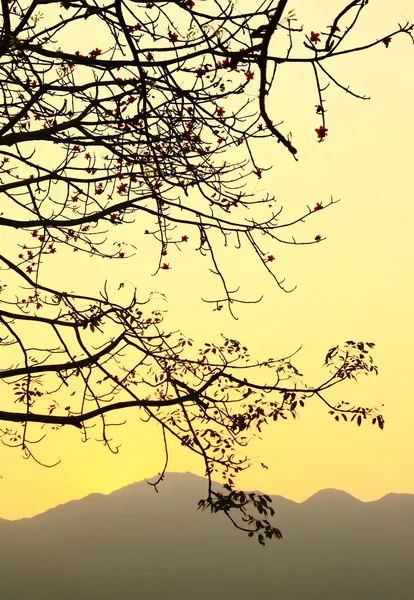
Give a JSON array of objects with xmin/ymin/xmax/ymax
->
[{"xmin": 0, "ymin": 0, "xmax": 413, "ymax": 544}]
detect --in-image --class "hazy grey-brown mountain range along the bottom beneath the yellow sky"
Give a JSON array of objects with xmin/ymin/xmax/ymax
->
[{"xmin": 0, "ymin": 473, "xmax": 414, "ymax": 600}]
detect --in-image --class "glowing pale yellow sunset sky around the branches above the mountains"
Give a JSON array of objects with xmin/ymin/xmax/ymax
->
[{"xmin": 0, "ymin": 0, "xmax": 414, "ymax": 519}]
